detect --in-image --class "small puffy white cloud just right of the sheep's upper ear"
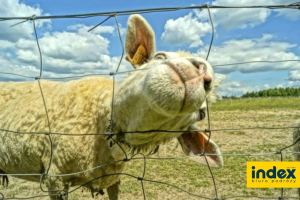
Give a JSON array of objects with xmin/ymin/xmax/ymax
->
[{"xmin": 161, "ymin": 13, "xmax": 211, "ymax": 47}]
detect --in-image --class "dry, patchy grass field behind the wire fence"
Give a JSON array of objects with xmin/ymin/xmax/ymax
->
[{"xmin": 0, "ymin": 98, "xmax": 300, "ymax": 200}]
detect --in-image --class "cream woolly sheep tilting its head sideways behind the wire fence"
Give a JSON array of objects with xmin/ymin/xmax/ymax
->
[{"xmin": 0, "ymin": 15, "xmax": 223, "ymax": 200}]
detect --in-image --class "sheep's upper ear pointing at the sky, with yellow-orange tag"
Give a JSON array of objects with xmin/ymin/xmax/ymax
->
[{"xmin": 125, "ymin": 14, "xmax": 156, "ymax": 68}]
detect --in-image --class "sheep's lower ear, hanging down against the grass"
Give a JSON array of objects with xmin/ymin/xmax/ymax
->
[{"xmin": 178, "ymin": 128, "xmax": 223, "ymax": 167}]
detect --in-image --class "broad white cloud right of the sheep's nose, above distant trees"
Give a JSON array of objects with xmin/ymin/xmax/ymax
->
[{"xmin": 195, "ymin": 34, "xmax": 300, "ymax": 96}]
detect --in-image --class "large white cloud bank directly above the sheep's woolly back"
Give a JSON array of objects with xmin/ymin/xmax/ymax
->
[{"xmin": 0, "ymin": 23, "xmax": 131, "ymax": 77}]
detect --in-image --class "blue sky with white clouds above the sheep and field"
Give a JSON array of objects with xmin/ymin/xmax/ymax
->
[{"xmin": 0, "ymin": 0, "xmax": 300, "ymax": 96}]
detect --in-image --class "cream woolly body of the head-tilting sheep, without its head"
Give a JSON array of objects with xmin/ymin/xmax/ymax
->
[{"xmin": 0, "ymin": 78, "xmax": 123, "ymax": 189}]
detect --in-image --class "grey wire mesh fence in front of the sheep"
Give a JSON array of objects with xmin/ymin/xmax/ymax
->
[{"xmin": 0, "ymin": 2, "xmax": 300, "ymax": 200}]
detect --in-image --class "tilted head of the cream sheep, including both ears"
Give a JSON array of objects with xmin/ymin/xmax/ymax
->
[{"xmin": 114, "ymin": 15, "xmax": 223, "ymax": 166}]
